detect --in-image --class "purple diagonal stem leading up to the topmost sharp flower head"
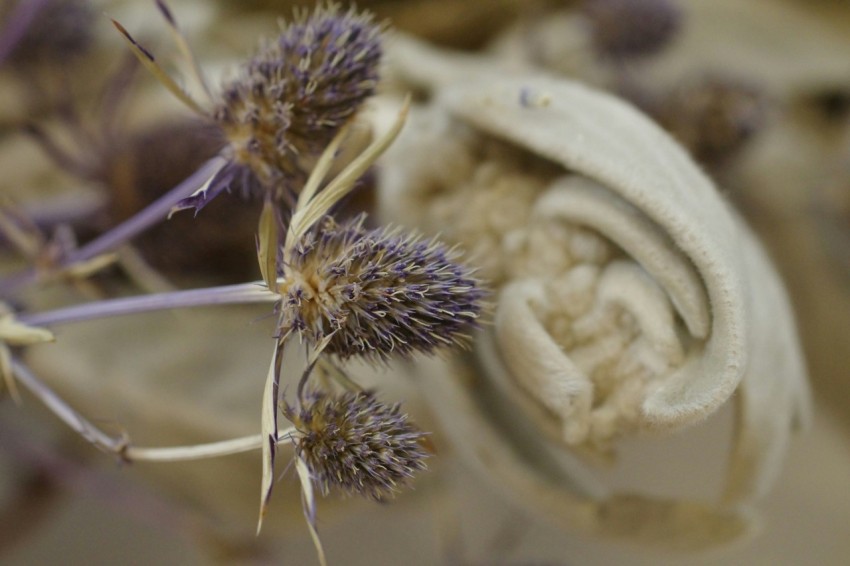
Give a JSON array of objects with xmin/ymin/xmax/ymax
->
[{"xmin": 0, "ymin": 157, "xmax": 224, "ymax": 297}]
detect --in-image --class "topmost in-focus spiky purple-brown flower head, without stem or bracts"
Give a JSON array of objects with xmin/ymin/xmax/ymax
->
[{"xmin": 212, "ymin": 5, "xmax": 382, "ymax": 197}]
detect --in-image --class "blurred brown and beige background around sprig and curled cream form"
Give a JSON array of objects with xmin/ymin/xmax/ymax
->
[{"xmin": 0, "ymin": 0, "xmax": 850, "ymax": 565}]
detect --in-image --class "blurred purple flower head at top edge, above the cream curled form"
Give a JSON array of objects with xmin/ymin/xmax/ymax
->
[{"xmin": 582, "ymin": 0, "xmax": 682, "ymax": 59}]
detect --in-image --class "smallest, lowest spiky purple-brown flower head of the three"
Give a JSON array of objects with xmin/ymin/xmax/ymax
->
[{"xmin": 283, "ymin": 391, "xmax": 428, "ymax": 500}]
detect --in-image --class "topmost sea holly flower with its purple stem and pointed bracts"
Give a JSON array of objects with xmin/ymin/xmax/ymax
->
[{"xmin": 0, "ymin": 0, "xmax": 392, "ymax": 296}]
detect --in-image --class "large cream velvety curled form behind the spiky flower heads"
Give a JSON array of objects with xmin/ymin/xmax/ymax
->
[{"xmin": 378, "ymin": 37, "xmax": 809, "ymax": 548}]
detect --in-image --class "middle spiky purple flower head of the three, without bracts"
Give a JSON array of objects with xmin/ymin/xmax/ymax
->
[{"xmin": 280, "ymin": 215, "xmax": 484, "ymax": 360}]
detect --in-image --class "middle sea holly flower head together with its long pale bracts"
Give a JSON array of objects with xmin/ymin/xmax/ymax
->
[{"xmin": 232, "ymin": 95, "xmax": 483, "ymax": 555}]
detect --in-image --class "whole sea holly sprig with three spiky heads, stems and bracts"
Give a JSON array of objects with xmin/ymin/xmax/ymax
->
[{"xmin": 0, "ymin": 5, "xmax": 476, "ymax": 563}]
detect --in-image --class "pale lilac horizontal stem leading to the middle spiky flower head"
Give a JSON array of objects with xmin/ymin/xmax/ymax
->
[{"xmin": 17, "ymin": 282, "xmax": 280, "ymax": 327}]
